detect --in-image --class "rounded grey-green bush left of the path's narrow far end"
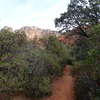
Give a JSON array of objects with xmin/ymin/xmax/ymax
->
[{"xmin": 22, "ymin": 48, "xmax": 61, "ymax": 76}]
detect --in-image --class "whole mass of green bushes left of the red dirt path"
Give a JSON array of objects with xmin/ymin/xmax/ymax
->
[{"xmin": 0, "ymin": 30, "xmax": 70, "ymax": 97}]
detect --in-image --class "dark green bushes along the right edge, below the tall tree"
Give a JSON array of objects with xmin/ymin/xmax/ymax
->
[{"xmin": 72, "ymin": 25, "xmax": 100, "ymax": 100}]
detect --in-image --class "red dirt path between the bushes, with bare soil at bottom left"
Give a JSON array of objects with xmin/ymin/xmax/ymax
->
[{"xmin": 0, "ymin": 66, "xmax": 74, "ymax": 100}]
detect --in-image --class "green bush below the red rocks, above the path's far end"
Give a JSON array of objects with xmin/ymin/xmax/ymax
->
[{"xmin": 46, "ymin": 36, "xmax": 73, "ymax": 66}]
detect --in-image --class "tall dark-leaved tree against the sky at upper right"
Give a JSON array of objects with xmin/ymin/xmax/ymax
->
[{"xmin": 55, "ymin": 0, "xmax": 100, "ymax": 37}]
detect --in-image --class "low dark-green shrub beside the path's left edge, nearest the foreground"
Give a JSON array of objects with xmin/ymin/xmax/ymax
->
[{"xmin": 24, "ymin": 76, "xmax": 51, "ymax": 98}]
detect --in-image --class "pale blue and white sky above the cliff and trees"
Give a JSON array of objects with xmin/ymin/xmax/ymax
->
[{"xmin": 0, "ymin": 0, "xmax": 69, "ymax": 30}]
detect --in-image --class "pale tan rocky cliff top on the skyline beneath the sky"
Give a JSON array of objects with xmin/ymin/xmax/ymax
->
[{"xmin": 16, "ymin": 26, "xmax": 59, "ymax": 40}]
